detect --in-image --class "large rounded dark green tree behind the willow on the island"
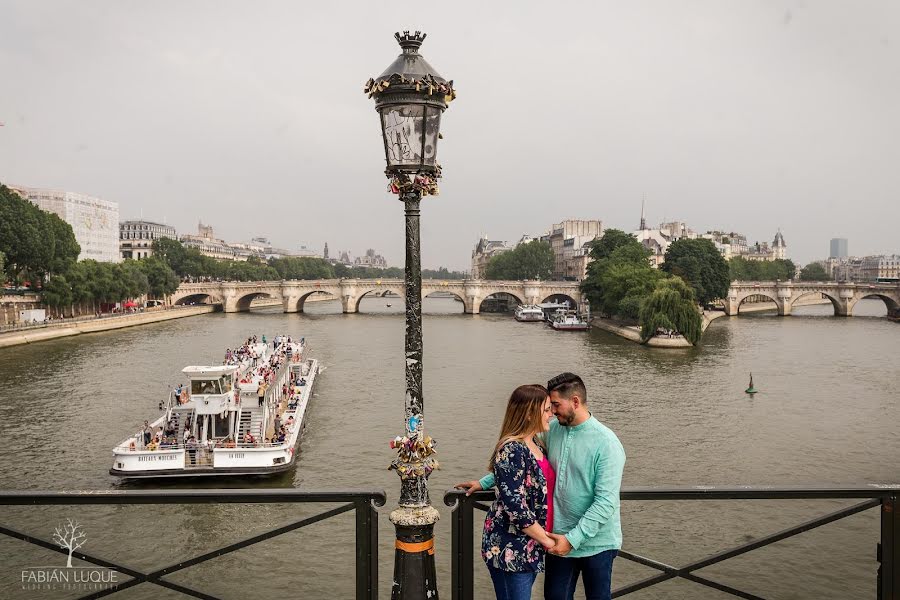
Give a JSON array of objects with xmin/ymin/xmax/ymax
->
[{"xmin": 660, "ymin": 238, "xmax": 731, "ymax": 304}]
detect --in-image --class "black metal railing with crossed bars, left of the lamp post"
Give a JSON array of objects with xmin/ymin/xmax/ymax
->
[{"xmin": 0, "ymin": 489, "xmax": 386, "ymax": 600}]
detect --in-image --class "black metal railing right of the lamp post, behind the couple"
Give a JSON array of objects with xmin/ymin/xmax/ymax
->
[{"xmin": 444, "ymin": 484, "xmax": 900, "ymax": 600}]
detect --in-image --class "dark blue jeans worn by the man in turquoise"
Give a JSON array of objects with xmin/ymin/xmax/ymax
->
[{"xmin": 544, "ymin": 550, "xmax": 619, "ymax": 600}]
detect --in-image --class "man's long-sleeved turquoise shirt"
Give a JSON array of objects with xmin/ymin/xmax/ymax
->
[{"xmin": 480, "ymin": 416, "xmax": 625, "ymax": 558}]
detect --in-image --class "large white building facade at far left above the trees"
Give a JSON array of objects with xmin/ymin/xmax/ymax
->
[{"xmin": 10, "ymin": 186, "xmax": 120, "ymax": 262}]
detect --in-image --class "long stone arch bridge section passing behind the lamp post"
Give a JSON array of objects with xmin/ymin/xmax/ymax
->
[{"xmin": 171, "ymin": 279, "xmax": 581, "ymax": 314}]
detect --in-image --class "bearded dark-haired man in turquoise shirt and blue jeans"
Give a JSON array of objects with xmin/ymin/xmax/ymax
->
[{"xmin": 456, "ymin": 373, "xmax": 625, "ymax": 600}]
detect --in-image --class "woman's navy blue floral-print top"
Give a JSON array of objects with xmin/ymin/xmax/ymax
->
[{"xmin": 481, "ymin": 441, "xmax": 547, "ymax": 572}]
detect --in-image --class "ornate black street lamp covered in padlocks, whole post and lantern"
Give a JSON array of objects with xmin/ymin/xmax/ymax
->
[{"xmin": 365, "ymin": 31, "xmax": 456, "ymax": 600}]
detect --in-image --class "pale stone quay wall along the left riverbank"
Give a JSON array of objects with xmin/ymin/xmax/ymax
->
[{"xmin": 0, "ymin": 304, "xmax": 218, "ymax": 348}]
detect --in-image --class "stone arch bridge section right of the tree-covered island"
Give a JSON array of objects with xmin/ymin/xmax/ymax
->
[{"xmin": 724, "ymin": 281, "xmax": 900, "ymax": 319}]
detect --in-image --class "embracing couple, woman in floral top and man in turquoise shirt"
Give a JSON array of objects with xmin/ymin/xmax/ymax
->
[{"xmin": 456, "ymin": 373, "xmax": 625, "ymax": 600}]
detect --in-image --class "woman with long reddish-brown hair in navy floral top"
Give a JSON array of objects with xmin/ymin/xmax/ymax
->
[{"xmin": 481, "ymin": 385, "xmax": 555, "ymax": 600}]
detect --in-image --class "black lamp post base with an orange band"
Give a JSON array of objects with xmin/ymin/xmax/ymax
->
[{"xmin": 390, "ymin": 506, "xmax": 439, "ymax": 600}]
